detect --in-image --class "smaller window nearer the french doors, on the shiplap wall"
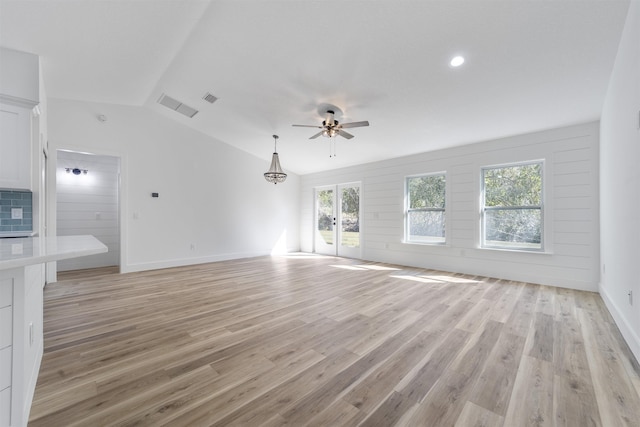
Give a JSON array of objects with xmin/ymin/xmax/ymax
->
[{"xmin": 405, "ymin": 173, "xmax": 446, "ymax": 243}]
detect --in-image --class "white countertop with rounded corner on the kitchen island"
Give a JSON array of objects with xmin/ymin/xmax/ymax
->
[{"xmin": 0, "ymin": 236, "xmax": 107, "ymax": 270}]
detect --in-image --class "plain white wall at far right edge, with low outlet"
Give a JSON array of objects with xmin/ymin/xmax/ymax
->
[{"xmin": 600, "ymin": 1, "xmax": 640, "ymax": 360}]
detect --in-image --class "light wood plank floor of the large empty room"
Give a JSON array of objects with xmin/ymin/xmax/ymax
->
[{"xmin": 29, "ymin": 254, "xmax": 640, "ymax": 427}]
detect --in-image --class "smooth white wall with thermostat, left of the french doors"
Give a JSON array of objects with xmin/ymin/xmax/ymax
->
[{"xmin": 49, "ymin": 99, "xmax": 299, "ymax": 272}]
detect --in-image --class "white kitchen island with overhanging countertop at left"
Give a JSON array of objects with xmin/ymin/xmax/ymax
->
[{"xmin": 0, "ymin": 236, "xmax": 107, "ymax": 427}]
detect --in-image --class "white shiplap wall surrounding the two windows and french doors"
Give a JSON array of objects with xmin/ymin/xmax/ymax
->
[{"xmin": 300, "ymin": 122, "xmax": 599, "ymax": 291}]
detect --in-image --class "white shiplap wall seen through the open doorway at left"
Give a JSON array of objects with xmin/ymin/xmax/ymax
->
[{"xmin": 56, "ymin": 150, "xmax": 120, "ymax": 271}]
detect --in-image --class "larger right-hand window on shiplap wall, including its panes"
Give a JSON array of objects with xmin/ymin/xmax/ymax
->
[{"xmin": 482, "ymin": 162, "xmax": 543, "ymax": 250}]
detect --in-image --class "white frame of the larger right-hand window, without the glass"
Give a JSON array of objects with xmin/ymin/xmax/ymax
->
[{"xmin": 480, "ymin": 159, "xmax": 546, "ymax": 253}]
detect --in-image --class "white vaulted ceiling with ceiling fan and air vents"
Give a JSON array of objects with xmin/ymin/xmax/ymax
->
[{"xmin": 0, "ymin": 0, "xmax": 629, "ymax": 174}]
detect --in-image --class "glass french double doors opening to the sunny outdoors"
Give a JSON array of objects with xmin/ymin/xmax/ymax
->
[{"xmin": 314, "ymin": 183, "xmax": 361, "ymax": 258}]
